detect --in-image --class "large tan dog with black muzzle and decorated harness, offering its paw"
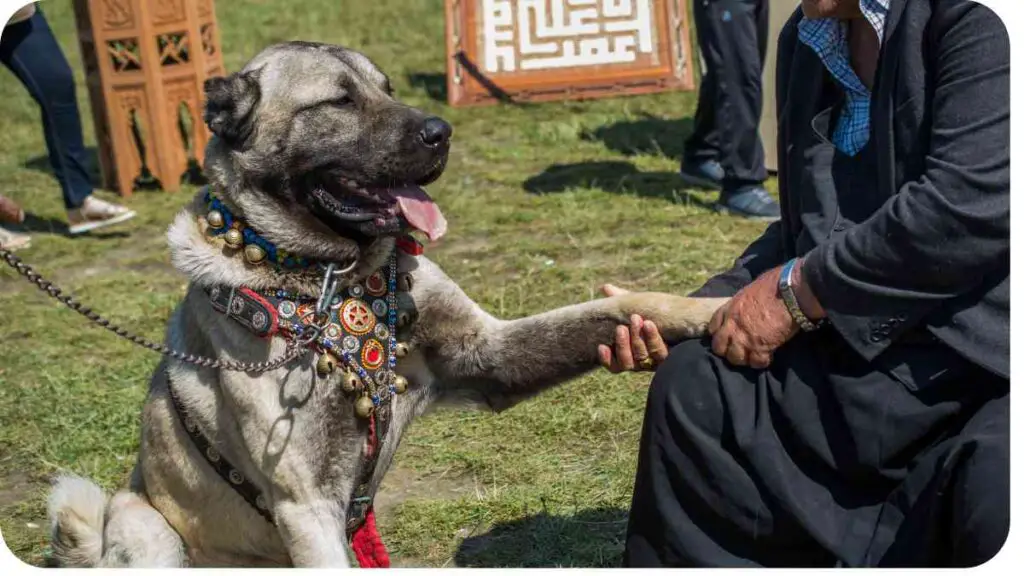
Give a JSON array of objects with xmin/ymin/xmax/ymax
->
[{"xmin": 49, "ymin": 42, "xmax": 724, "ymax": 567}]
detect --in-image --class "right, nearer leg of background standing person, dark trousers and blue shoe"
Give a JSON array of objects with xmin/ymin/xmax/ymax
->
[{"xmin": 697, "ymin": 0, "xmax": 779, "ymax": 219}]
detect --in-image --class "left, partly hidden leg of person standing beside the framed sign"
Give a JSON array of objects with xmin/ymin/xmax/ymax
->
[{"xmin": 679, "ymin": 0, "xmax": 724, "ymax": 190}]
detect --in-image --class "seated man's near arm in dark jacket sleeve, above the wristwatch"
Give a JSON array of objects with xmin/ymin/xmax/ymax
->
[{"xmin": 802, "ymin": 2, "xmax": 1010, "ymax": 360}]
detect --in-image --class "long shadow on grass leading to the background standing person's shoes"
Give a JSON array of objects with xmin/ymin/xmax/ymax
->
[{"xmin": 522, "ymin": 160, "xmax": 714, "ymax": 210}]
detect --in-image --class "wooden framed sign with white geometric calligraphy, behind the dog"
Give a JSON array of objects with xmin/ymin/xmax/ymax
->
[{"xmin": 444, "ymin": 0, "xmax": 694, "ymax": 106}]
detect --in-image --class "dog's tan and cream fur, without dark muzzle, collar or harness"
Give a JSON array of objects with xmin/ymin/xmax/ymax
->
[{"xmin": 50, "ymin": 44, "xmax": 721, "ymax": 567}]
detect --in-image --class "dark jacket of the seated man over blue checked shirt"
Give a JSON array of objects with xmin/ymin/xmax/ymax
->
[{"xmin": 694, "ymin": 0, "xmax": 1010, "ymax": 378}]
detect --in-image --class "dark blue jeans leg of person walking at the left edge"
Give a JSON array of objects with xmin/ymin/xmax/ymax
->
[{"xmin": 0, "ymin": 7, "xmax": 92, "ymax": 209}]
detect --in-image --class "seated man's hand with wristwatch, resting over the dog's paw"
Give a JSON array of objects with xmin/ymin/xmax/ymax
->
[{"xmin": 708, "ymin": 256, "xmax": 825, "ymax": 369}]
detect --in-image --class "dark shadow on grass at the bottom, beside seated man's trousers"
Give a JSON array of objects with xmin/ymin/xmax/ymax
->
[{"xmin": 455, "ymin": 507, "xmax": 629, "ymax": 568}]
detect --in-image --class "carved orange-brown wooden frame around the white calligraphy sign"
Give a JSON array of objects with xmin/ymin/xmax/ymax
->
[{"xmin": 444, "ymin": 0, "xmax": 694, "ymax": 107}]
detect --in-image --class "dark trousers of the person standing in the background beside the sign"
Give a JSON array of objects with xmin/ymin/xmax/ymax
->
[{"xmin": 684, "ymin": 0, "xmax": 768, "ymax": 191}]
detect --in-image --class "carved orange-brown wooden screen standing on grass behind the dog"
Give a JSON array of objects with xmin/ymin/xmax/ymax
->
[{"xmin": 74, "ymin": 0, "xmax": 223, "ymax": 196}]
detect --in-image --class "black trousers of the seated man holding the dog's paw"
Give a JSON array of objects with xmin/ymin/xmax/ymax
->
[{"xmin": 624, "ymin": 330, "xmax": 1010, "ymax": 567}]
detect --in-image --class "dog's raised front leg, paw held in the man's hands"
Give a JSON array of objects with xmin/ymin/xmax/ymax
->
[{"xmin": 413, "ymin": 255, "xmax": 727, "ymax": 410}]
